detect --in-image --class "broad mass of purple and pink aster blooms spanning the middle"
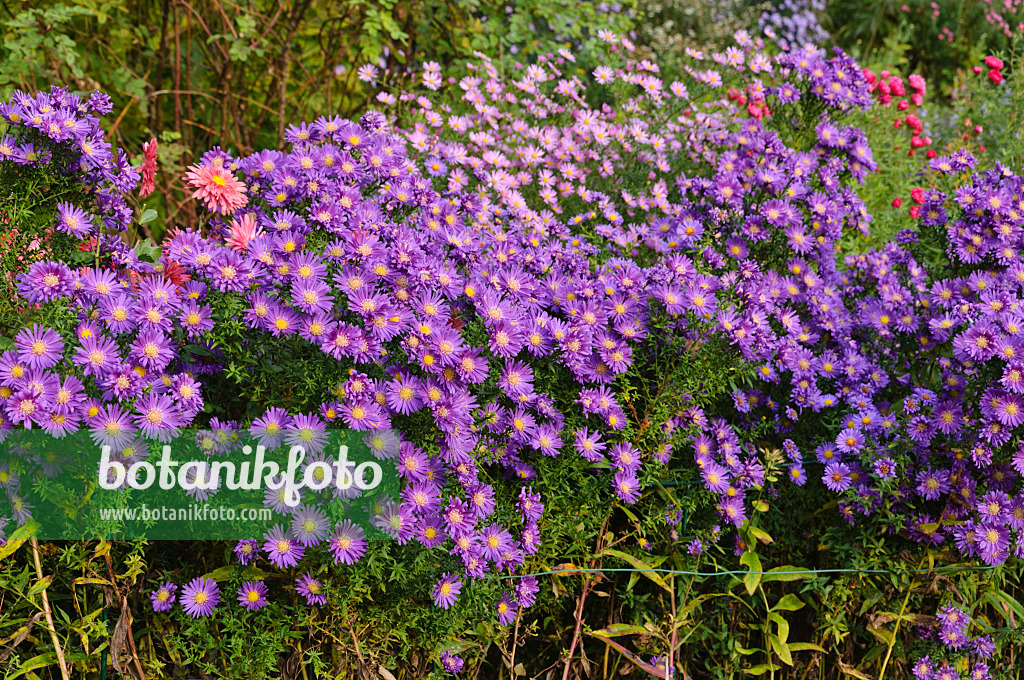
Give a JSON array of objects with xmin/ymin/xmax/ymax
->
[{"xmin": 9, "ymin": 27, "xmax": 1024, "ymax": 639}]
